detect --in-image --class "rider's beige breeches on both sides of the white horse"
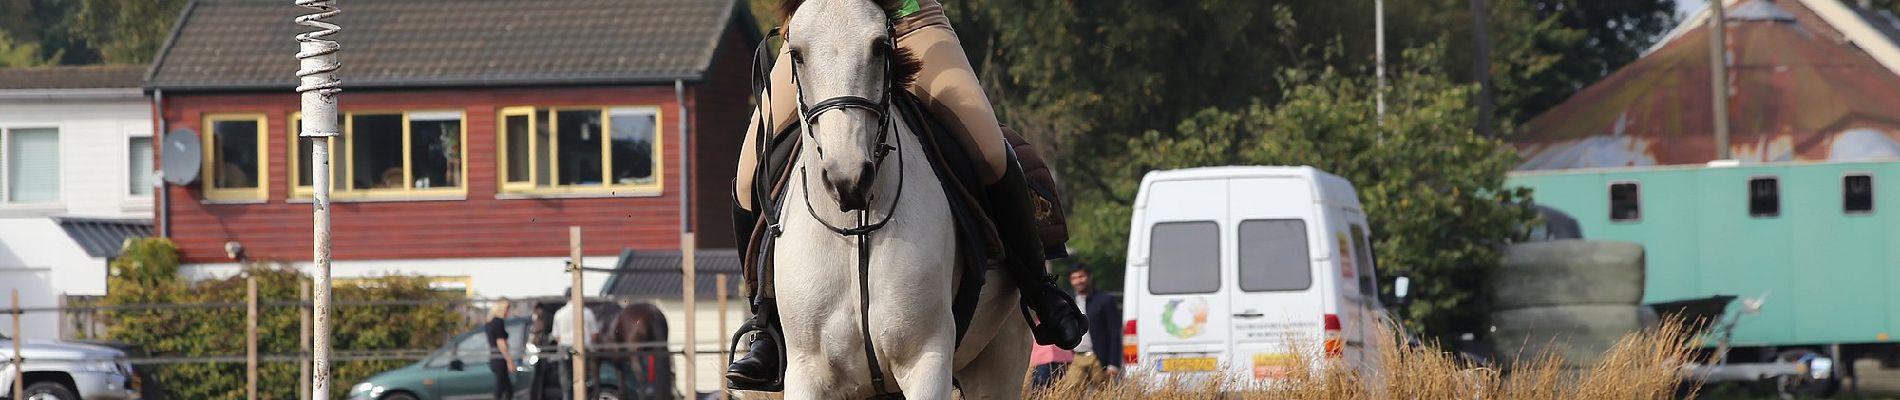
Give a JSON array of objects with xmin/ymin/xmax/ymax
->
[{"xmin": 733, "ymin": 25, "xmax": 1009, "ymax": 210}]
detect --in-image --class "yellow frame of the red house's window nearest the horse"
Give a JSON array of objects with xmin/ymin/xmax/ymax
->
[{"xmin": 496, "ymin": 104, "xmax": 667, "ymax": 195}]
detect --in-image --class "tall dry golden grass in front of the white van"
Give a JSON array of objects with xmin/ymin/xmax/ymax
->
[{"xmin": 1030, "ymin": 322, "xmax": 1697, "ymax": 400}]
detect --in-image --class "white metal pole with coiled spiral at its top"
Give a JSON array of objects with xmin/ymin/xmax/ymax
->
[{"xmin": 296, "ymin": 0, "xmax": 342, "ymax": 398}]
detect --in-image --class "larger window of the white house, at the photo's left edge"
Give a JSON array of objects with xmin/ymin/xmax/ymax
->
[{"xmin": 0, "ymin": 127, "xmax": 59, "ymax": 203}]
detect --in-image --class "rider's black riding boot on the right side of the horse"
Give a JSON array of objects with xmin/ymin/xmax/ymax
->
[{"xmin": 984, "ymin": 157, "xmax": 1089, "ymax": 349}]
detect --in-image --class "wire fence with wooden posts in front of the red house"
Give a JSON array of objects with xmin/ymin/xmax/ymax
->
[{"xmin": 0, "ymin": 269, "xmax": 747, "ymax": 398}]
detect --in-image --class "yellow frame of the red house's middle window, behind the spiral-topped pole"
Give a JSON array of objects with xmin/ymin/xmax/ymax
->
[{"xmin": 291, "ymin": 110, "xmax": 469, "ymax": 199}]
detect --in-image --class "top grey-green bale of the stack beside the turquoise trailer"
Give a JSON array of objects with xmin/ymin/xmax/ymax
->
[{"xmin": 1492, "ymin": 241, "xmax": 1644, "ymax": 309}]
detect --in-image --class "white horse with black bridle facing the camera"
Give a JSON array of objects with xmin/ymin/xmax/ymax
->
[{"xmin": 773, "ymin": 0, "xmax": 1032, "ymax": 400}]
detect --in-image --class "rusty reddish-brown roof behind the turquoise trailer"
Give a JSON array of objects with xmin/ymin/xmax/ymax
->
[{"xmin": 1511, "ymin": 0, "xmax": 1900, "ymax": 169}]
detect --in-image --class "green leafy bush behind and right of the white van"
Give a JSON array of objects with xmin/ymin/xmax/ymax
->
[{"xmin": 1077, "ymin": 45, "xmax": 1535, "ymax": 337}]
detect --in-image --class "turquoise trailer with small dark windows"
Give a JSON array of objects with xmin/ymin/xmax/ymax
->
[{"xmin": 1509, "ymin": 161, "xmax": 1900, "ymax": 384}]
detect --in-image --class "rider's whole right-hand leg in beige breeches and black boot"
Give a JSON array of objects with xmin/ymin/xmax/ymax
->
[{"xmin": 897, "ymin": 25, "xmax": 1089, "ymax": 349}]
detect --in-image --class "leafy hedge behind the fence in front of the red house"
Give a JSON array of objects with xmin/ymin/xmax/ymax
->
[{"xmin": 105, "ymin": 239, "xmax": 464, "ymax": 398}]
